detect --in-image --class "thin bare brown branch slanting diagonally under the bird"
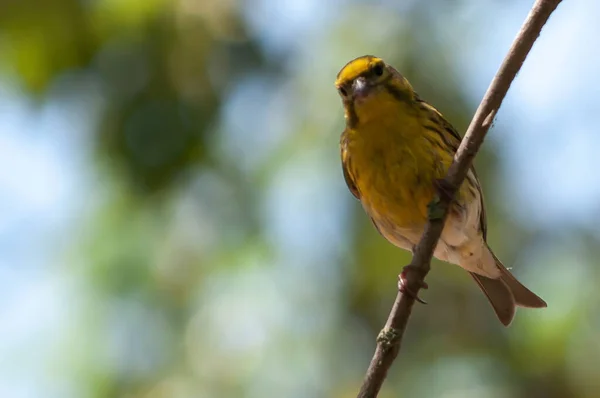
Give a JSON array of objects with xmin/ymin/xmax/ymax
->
[{"xmin": 358, "ymin": 0, "xmax": 561, "ymax": 398}]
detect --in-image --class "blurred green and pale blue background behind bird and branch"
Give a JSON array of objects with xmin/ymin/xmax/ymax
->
[{"xmin": 0, "ymin": 0, "xmax": 600, "ymax": 398}]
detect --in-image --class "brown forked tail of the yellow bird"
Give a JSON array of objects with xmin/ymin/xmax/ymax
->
[{"xmin": 470, "ymin": 249, "xmax": 547, "ymax": 326}]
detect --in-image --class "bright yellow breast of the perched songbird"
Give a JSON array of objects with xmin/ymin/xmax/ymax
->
[{"xmin": 344, "ymin": 93, "xmax": 452, "ymax": 228}]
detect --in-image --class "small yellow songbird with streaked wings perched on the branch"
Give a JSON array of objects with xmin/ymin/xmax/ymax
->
[{"xmin": 335, "ymin": 56, "xmax": 546, "ymax": 326}]
